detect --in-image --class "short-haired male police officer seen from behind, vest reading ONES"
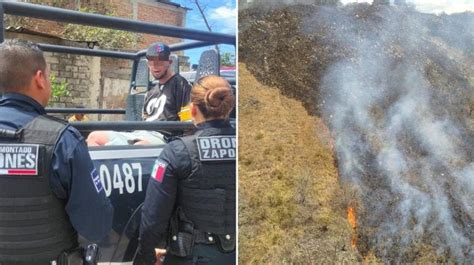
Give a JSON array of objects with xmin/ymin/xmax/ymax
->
[{"xmin": 0, "ymin": 40, "xmax": 113, "ymax": 265}]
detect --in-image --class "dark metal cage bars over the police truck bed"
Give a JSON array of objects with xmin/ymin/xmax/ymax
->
[{"xmin": 0, "ymin": 0, "xmax": 236, "ymax": 131}]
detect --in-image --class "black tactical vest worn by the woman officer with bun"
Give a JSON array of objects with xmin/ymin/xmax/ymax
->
[{"xmin": 177, "ymin": 128, "xmax": 236, "ymax": 235}]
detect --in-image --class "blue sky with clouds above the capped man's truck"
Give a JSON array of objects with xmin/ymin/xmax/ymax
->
[{"xmin": 172, "ymin": 0, "xmax": 237, "ymax": 67}]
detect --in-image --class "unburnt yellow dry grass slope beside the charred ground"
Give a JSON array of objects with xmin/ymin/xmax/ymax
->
[{"xmin": 239, "ymin": 64, "xmax": 357, "ymax": 264}]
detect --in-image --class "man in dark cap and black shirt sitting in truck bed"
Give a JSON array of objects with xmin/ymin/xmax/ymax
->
[{"xmin": 87, "ymin": 42, "xmax": 191, "ymax": 146}]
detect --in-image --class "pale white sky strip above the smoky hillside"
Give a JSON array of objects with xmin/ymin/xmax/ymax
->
[{"xmin": 341, "ymin": 0, "xmax": 474, "ymax": 14}]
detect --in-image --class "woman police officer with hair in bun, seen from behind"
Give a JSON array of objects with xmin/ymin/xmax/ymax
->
[{"xmin": 134, "ymin": 76, "xmax": 236, "ymax": 264}]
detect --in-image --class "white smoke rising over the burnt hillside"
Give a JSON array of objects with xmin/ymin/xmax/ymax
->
[{"xmin": 305, "ymin": 5, "xmax": 474, "ymax": 263}]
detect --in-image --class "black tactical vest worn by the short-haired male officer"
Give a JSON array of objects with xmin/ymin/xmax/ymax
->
[{"xmin": 0, "ymin": 116, "xmax": 77, "ymax": 265}]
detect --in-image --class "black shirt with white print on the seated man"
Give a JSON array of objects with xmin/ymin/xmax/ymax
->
[{"xmin": 143, "ymin": 74, "xmax": 191, "ymax": 121}]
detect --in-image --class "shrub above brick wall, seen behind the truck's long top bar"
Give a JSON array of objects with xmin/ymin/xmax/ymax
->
[{"xmin": 63, "ymin": 8, "xmax": 142, "ymax": 49}]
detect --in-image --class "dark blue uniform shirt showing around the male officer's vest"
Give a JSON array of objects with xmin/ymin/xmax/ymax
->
[{"xmin": 0, "ymin": 93, "xmax": 113, "ymax": 241}]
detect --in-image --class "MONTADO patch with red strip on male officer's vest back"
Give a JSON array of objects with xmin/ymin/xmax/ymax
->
[{"xmin": 0, "ymin": 144, "xmax": 40, "ymax": 176}]
